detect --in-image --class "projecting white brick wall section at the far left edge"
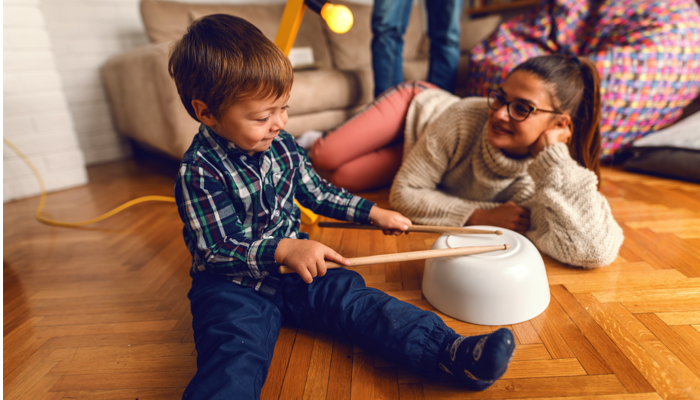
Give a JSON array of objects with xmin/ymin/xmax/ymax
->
[{"xmin": 3, "ymin": 0, "xmax": 87, "ymax": 201}]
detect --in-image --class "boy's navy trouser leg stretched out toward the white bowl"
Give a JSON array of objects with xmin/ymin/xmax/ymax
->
[{"xmin": 275, "ymin": 268, "xmax": 454, "ymax": 376}]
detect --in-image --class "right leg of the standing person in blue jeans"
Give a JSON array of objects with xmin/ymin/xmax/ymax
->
[{"xmin": 425, "ymin": 0, "xmax": 462, "ymax": 92}]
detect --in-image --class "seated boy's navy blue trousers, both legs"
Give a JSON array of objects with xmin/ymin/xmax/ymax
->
[{"xmin": 183, "ymin": 268, "xmax": 454, "ymax": 399}]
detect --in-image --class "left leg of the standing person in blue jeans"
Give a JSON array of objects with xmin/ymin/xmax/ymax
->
[{"xmin": 372, "ymin": 0, "xmax": 413, "ymax": 97}]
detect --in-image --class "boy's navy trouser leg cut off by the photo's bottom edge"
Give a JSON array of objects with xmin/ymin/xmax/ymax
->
[{"xmin": 183, "ymin": 272, "xmax": 281, "ymax": 400}]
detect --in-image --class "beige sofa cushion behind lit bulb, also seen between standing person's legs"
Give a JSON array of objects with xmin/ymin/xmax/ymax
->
[{"xmin": 323, "ymin": 1, "xmax": 423, "ymax": 71}]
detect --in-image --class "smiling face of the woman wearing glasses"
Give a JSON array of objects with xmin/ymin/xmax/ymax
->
[{"xmin": 486, "ymin": 71, "xmax": 569, "ymax": 158}]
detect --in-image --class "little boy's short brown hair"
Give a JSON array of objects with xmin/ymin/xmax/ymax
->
[{"xmin": 168, "ymin": 14, "xmax": 294, "ymax": 122}]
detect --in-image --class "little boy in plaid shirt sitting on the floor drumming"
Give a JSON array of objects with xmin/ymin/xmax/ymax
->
[{"xmin": 169, "ymin": 14, "xmax": 515, "ymax": 399}]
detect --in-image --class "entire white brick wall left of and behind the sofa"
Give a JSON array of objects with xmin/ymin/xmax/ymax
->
[{"xmin": 3, "ymin": 0, "xmax": 372, "ymax": 201}]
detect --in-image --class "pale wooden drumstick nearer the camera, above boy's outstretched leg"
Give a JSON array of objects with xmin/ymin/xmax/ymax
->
[{"xmin": 280, "ymin": 244, "xmax": 510, "ymax": 274}]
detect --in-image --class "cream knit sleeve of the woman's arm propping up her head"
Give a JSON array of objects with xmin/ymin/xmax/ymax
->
[{"xmin": 523, "ymin": 143, "xmax": 624, "ymax": 268}]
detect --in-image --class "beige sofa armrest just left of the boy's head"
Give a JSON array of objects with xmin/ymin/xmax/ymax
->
[{"xmin": 100, "ymin": 42, "xmax": 199, "ymax": 159}]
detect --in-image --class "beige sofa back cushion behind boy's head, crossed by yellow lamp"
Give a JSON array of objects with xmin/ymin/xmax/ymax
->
[{"xmin": 141, "ymin": 0, "xmax": 332, "ymax": 68}]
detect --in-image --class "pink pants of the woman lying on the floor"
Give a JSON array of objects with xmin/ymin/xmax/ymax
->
[{"xmin": 311, "ymin": 81, "xmax": 437, "ymax": 192}]
